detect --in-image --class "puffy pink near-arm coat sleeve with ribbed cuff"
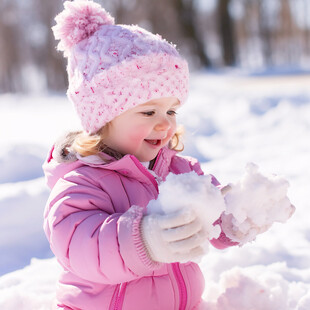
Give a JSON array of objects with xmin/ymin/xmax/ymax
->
[{"xmin": 44, "ymin": 168, "xmax": 159, "ymax": 284}]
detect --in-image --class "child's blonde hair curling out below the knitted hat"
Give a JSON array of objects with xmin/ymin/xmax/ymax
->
[{"xmin": 71, "ymin": 123, "xmax": 184, "ymax": 157}]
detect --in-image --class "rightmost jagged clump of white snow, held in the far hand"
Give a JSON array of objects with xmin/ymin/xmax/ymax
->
[{"xmin": 223, "ymin": 163, "xmax": 295, "ymax": 243}]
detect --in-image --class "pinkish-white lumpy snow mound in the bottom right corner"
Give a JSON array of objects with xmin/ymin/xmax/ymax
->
[{"xmin": 202, "ymin": 263, "xmax": 310, "ymax": 310}]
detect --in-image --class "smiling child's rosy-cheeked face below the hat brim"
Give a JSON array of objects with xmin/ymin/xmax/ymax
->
[{"xmin": 104, "ymin": 97, "xmax": 180, "ymax": 162}]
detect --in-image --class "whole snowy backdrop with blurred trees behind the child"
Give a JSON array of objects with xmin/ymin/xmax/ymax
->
[{"xmin": 0, "ymin": 0, "xmax": 310, "ymax": 310}]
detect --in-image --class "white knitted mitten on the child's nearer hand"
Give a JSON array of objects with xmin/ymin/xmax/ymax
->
[{"xmin": 141, "ymin": 210, "xmax": 206, "ymax": 263}]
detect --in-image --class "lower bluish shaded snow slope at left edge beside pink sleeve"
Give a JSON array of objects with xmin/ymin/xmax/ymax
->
[{"xmin": 0, "ymin": 178, "xmax": 51, "ymax": 275}]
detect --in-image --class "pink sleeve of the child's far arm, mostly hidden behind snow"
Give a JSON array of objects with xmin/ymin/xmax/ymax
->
[{"xmin": 170, "ymin": 156, "xmax": 239, "ymax": 250}]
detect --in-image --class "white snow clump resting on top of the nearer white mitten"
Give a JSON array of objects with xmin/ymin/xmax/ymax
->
[{"xmin": 148, "ymin": 172, "xmax": 225, "ymax": 239}]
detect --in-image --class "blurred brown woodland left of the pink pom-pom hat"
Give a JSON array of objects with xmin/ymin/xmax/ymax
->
[{"xmin": 0, "ymin": 0, "xmax": 67, "ymax": 92}]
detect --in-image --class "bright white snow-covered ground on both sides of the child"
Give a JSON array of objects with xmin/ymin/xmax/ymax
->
[{"xmin": 0, "ymin": 73, "xmax": 310, "ymax": 310}]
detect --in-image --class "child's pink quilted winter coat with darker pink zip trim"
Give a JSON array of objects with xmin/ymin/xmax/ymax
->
[{"xmin": 44, "ymin": 143, "xmax": 235, "ymax": 310}]
